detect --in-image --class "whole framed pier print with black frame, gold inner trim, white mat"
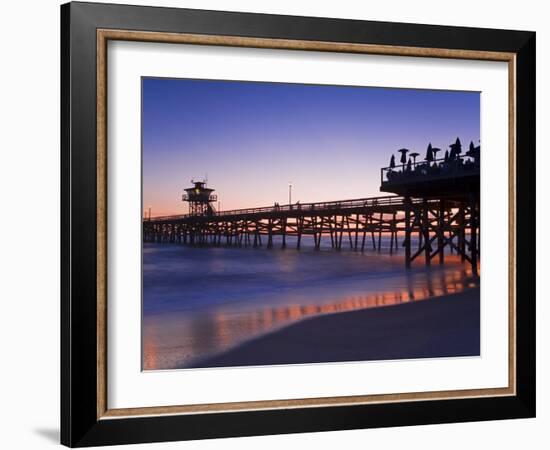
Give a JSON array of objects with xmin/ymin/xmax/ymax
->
[{"xmin": 61, "ymin": 3, "xmax": 535, "ymax": 446}]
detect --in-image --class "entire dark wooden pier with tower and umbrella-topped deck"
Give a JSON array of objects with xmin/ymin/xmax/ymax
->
[{"xmin": 143, "ymin": 138, "xmax": 480, "ymax": 274}]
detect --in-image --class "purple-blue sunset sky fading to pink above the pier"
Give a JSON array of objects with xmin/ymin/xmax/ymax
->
[{"xmin": 142, "ymin": 78, "xmax": 480, "ymax": 216}]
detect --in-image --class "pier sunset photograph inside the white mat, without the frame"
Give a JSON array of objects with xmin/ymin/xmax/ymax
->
[{"xmin": 141, "ymin": 76, "xmax": 484, "ymax": 371}]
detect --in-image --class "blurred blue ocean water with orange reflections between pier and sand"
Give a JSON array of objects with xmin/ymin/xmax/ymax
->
[{"xmin": 142, "ymin": 239, "xmax": 479, "ymax": 370}]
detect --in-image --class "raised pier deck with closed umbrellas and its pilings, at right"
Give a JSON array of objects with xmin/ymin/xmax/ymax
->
[{"xmin": 380, "ymin": 138, "xmax": 480, "ymax": 275}]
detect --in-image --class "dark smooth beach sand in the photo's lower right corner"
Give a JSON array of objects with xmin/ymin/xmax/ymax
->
[{"xmin": 193, "ymin": 288, "xmax": 480, "ymax": 367}]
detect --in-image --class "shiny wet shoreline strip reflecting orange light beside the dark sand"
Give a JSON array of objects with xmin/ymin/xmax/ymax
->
[{"xmin": 143, "ymin": 266, "xmax": 479, "ymax": 370}]
